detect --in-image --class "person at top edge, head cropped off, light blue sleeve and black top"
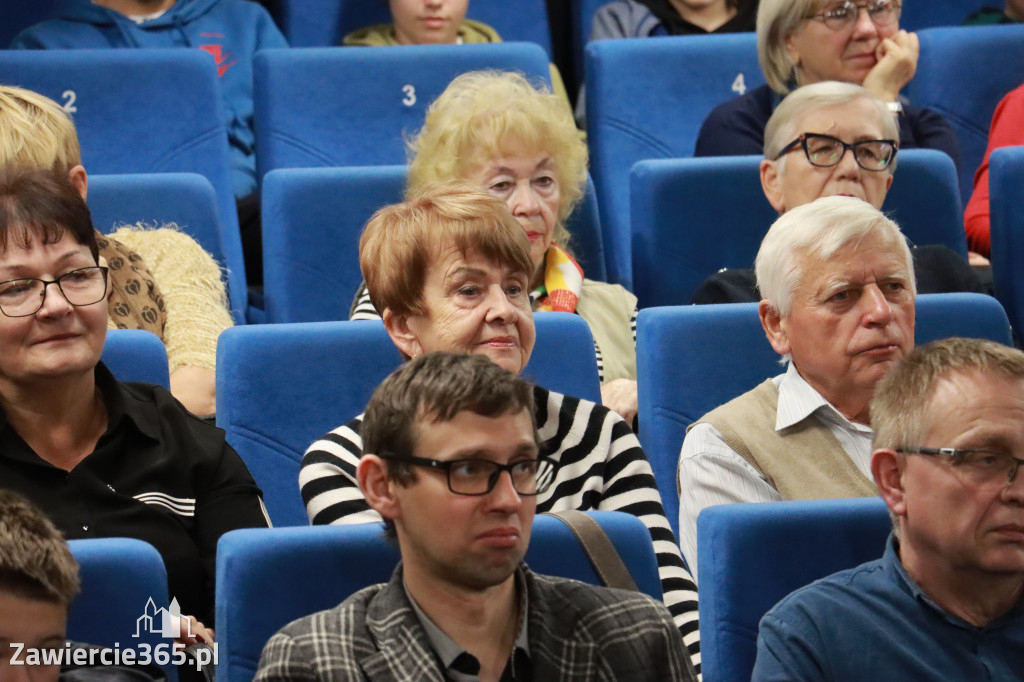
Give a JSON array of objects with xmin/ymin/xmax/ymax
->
[{"xmin": 590, "ymin": 0, "xmax": 758, "ymax": 40}]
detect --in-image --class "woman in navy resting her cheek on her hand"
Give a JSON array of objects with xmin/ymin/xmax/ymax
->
[{"xmin": 695, "ymin": 0, "xmax": 959, "ymax": 164}]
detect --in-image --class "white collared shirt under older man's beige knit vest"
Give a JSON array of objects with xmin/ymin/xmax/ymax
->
[{"xmin": 678, "ymin": 363, "xmax": 873, "ymax": 580}]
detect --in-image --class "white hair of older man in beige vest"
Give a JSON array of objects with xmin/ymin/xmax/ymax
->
[{"xmin": 754, "ymin": 197, "xmax": 916, "ymax": 316}]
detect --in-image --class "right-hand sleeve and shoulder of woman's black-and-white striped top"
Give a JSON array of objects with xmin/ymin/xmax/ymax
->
[{"xmin": 535, "ymin": 387, "xmax": 700, "ymax": 671}]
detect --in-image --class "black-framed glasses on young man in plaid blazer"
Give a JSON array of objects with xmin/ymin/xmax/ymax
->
[{"xmin": 381, "ymin": 455, "xmax": 555, "ymax": 496}]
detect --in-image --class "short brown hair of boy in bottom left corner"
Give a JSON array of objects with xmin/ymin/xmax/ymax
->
[{"xmin": 0, "ymin": 489, "xmax": 79, "ymax": 606}]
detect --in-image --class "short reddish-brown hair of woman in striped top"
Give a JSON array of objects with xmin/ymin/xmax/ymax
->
[{"xmin": 359, "ymin": 184, "xmax": 534, "ymax": 314}]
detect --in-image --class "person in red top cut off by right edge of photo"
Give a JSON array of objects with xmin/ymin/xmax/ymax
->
[{"xmin": 964, "ymin": 85, "xmax": 1024, "ymax": 257}]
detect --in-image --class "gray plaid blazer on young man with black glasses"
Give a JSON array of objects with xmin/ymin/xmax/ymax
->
[{"xmin": 256, "ymin": 563, "xmax": 697, "ymax": 682}]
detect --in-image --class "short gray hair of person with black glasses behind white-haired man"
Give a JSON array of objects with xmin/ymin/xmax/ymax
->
[{"xmin": 764, "ymin": 81, "xmax": 899, "ymax": 168}]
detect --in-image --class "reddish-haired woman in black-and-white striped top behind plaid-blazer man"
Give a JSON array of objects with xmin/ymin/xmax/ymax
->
[{"xmin": 299, "ymin": 183, "xmax": 699, "ymax": 665}]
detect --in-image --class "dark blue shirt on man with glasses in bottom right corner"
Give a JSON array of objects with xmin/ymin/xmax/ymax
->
[{"xmin": 753, "ymin": 537, "xmax": 1024, "ymax": 682}]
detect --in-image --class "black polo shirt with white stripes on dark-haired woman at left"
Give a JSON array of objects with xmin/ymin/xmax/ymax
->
[{"xmin": 0, "ymin": 364, "xmax": 269, "ymax": 625}]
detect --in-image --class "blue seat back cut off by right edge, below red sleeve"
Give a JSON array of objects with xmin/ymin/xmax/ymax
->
[{"xmin": 988, "ymin": 146, "xmax": 1024, "ymax": 334}]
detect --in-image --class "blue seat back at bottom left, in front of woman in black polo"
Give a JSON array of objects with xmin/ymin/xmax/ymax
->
[{"xmin": 68, "ymin": 538, "xmax": 171, "ymax": 667}]
